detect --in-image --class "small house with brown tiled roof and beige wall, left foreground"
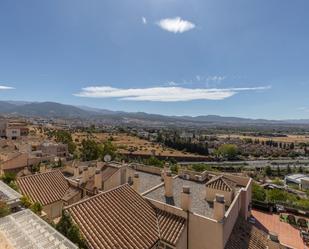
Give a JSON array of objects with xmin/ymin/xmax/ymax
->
[{"xmin": 17, "ymin": 170, "xmax": 81, "ymax": 219}]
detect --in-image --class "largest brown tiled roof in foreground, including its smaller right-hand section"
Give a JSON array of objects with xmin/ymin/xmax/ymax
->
[{"xmin": 67, "ymin": 184, "xmax": 185, "ymax": 249}]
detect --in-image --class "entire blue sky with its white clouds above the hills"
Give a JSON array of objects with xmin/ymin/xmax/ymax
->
[{"xmin": 0, "ymin": 0, "xmax": 309, "ymax": 119}]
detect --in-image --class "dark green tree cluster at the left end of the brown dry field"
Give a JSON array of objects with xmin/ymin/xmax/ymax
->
[{"xmin": 80, "ymin": 139, "xmax": 116, "ymax": 161}]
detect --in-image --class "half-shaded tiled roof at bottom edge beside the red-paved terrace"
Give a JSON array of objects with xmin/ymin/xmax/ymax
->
[{"xmin": 225, "ymin": 218, "xmax": 268, "ymax": 249}]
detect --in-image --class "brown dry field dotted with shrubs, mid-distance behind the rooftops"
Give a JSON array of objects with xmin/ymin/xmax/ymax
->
[{"xmin": 73, "ymin": 133, "xmax": 195, "ymax": 157}]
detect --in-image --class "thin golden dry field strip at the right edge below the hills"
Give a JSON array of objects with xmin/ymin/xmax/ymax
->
[{"xmin": 218, "ymin": 134, "xmax": 309, "ymax": 143}]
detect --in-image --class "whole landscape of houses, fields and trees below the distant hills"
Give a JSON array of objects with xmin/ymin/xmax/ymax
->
[{"xmin": 0, "ymin": 112, "xmax": 309, "ymax": 249}]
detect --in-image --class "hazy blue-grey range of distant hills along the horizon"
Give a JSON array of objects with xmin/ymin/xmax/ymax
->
[{"xmin": 0, "ymin": 101, "xmax": 309, "ymax": 125}]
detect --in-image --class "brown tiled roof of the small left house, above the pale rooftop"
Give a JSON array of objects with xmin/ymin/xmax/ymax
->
[{"xmin": 17, "ymin": 170, "xmax": 69, "ymax": 206}]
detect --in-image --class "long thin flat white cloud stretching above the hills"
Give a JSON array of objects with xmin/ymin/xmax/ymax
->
[{"xmin": 74, "ymin": 86, "xmax": 270, "ymax": 102}]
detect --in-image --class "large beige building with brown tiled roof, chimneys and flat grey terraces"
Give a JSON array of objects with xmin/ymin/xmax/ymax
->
[{"xmin": 62, "ymin": 161, "xmax": 284, "ymax": 249}]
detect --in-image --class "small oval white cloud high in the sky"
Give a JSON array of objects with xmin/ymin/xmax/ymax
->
[{"xmin": 157, "ymin": 17, "xmax": 195, "ymax": 34}]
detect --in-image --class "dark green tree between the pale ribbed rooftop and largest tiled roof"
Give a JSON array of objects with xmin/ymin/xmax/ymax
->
[{"xmin": 56, "ymin": 211, "xmax": 87, "ymax": 249}]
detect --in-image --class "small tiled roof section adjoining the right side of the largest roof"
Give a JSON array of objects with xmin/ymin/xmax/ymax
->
[{"xmin": 157, "ymin": 209, "xmax": 186, "ymax": 245}]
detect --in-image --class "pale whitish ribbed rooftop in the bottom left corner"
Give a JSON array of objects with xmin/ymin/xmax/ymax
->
[{"xmin": 0, "ymin": 209, "xmax": 78, "ymax": 249}]
